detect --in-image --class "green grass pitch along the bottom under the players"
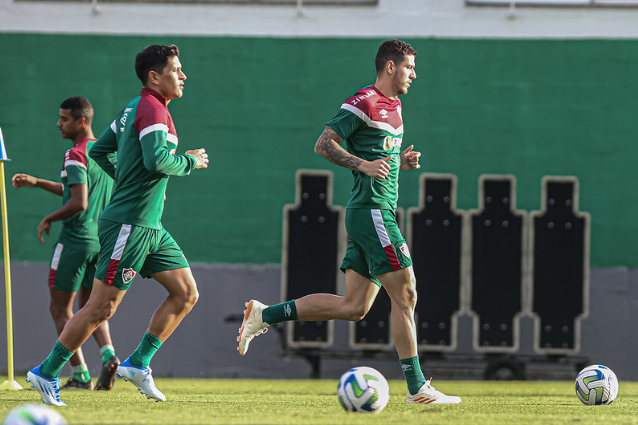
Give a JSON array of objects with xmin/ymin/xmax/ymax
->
[{"xmin": 0, "ymin": 376, "xmax": 638, "ymax": 425}]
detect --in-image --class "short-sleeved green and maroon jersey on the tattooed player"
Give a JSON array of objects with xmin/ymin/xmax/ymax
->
[{"xmin": 326, "ymin": 85, "xmax": 403, "ymax": 210}]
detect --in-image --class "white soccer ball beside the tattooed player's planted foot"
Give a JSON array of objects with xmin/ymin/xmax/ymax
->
[{"xmin": 337, "ymin": 366, "xmax": 390, "ymax": 413}]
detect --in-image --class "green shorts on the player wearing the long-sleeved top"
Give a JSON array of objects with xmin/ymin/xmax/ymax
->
[{"xmin": 95, "ymin": 219, "xmax": 189, "ymax": 290}]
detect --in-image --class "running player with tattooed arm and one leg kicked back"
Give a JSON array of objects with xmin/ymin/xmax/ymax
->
[{"xmin": 237, "ymin": 40, "xmax": 461, "ymax": 404}]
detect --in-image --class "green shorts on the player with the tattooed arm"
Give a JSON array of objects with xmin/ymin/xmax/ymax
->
[{"xmin": 341, "ymin": 208, "xmax": 412, "ymax": 286}]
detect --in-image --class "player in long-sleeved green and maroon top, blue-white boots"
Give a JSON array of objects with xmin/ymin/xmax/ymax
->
[{"xmin": 27, "ymin": 45, "xmax": 208, "ymax": 406}]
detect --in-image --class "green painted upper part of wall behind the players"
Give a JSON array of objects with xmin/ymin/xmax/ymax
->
[{"xmin": 0, "ymin": 34, "xmax": 638, "ymax": 267}]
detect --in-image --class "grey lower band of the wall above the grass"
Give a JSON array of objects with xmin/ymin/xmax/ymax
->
[{"xmin": 0, "ymin": 263, "xmax": 638, "ymax": 381}]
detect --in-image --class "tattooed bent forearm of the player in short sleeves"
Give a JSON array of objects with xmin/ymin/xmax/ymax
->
[{"xmin": 315, "ymin": 126, "xmax": 392, "ymax": 179}]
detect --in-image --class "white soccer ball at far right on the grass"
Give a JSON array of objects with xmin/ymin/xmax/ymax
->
[{"xmin": 576, "ymin": 364, "xmax": 618, "ymax": 406}]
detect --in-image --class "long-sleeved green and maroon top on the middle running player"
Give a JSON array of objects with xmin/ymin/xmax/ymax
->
[{"xmin": 89, "ymin": 88, "xmax": 196, "ymax": 229}]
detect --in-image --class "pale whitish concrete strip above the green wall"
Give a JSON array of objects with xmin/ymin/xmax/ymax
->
[{"xmin": 0, "ymin": 0, "xmax": 638, "ymax": 39}]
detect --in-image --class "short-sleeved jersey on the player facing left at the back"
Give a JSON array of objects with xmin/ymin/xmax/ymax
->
[{"xmin": 58, "ymin": 139, "xmax": 113, "ymax": 251}]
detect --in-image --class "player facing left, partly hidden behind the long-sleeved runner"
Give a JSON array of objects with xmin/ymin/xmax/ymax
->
[{"xmin": 12, "ymin": 96, "xmax": 120, "ymax": 390}]
